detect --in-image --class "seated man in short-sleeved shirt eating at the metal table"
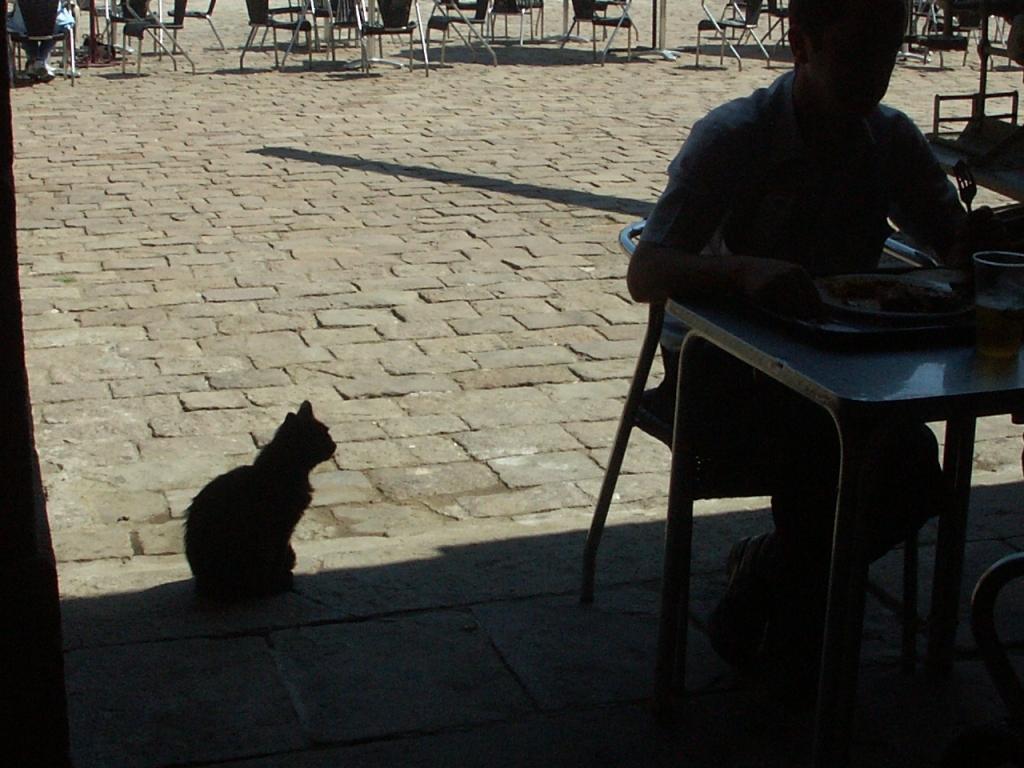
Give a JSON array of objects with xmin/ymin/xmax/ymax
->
[{"xmin": 628, "ymin": 0, "xmax": 990, "ymax": 693}]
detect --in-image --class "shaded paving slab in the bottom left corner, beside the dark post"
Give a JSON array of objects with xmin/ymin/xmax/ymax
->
[{"xmin": 66, "ymin": 638, "xmax": 304, "ymax": 768}]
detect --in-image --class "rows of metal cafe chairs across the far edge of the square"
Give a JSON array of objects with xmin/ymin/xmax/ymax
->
[{"xmin": 9, "ymin": 0, "xmax": 1024, "ymax": 77}]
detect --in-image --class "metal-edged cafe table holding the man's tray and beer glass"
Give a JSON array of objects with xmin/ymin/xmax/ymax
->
[{"xmin": 655, "ymin": 302, "xmax": 1024, "ymax": 768}]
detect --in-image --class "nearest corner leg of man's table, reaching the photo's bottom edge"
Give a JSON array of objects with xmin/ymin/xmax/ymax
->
[{"xmin": 812, "ymin": 415, "xmax": 872, "ymax": 768}]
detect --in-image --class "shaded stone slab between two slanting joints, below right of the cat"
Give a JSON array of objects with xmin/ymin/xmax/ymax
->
[{"xmin": 269, "ymin": 611, "xmax": 531, "ymax": 743}]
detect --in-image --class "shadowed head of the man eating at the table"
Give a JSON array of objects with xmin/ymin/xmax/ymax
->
[{"xmin": 790, "ymin": 0, "xmax": 906, "ymax": 118}]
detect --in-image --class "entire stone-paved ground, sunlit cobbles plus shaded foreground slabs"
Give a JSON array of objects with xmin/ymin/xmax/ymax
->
[{"xmin": 12, "ymin": 0, "xmax": 1024, "ymax": 766}]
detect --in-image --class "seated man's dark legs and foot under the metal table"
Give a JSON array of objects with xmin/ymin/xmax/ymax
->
[{"xmin": 710, "ymin": 376, "xmax": 945, "ymax": 697}]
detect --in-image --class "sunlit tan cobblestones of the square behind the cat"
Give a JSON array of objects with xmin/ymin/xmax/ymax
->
[{"xmin": 13, "ymin": 0, "xmax": 1020, "ymax": 560}]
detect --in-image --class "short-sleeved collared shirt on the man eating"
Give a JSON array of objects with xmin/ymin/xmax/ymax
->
[{"xmin": 641, "ymin": 71, "xmax": 966, "ymax": 344}]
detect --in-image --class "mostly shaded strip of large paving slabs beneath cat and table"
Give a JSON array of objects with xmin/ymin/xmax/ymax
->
[{"xmin": 61, "ymin": 487, "xmax": 1019, "ymax": 768}]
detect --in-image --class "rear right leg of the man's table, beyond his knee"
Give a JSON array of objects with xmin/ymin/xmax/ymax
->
[{"xmin": 927, "ymin": 417, "xmax": 976, "ymax": 670}]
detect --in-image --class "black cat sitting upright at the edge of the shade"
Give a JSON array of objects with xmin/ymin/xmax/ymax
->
[{"xmin": 185, "ymin": 400, "xmax": 335, "ymax": 600}]
